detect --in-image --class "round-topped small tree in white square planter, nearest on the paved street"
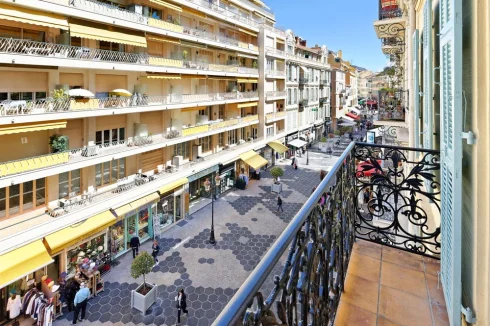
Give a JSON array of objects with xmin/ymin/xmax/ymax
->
[{"xmin": 131, "ymin": 251, "xmax": 157, "ymax": 314}]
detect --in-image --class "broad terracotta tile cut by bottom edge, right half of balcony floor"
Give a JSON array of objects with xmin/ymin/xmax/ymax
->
[{"xmin": 379, "ymin": 286, "xmax": 432, "ymax": 326}]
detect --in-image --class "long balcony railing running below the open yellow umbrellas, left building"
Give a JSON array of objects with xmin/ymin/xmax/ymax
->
[{"xmin": 0, "ymin": 92, "xmax": 259, "ymax": 117}]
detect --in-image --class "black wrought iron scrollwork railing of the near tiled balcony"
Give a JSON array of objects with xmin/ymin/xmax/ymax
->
[{"xmin": 213, "ymin": 142, "xmax": 440, "ymax": 326}]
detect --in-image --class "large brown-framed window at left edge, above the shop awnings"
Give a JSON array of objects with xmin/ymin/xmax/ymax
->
[{"xmin": 0, "ymin": 179, "xmax": 46, "ymax": 219}]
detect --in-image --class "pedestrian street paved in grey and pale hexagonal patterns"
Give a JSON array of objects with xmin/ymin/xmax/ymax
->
[{"xmin": 54, "ymin": 153, "xmax": 335, "ymax": 326}]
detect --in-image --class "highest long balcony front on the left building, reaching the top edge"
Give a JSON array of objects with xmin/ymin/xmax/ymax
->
[{"xmin": 42, "ymin": 0, "xmax": 258, "ymax": 51}]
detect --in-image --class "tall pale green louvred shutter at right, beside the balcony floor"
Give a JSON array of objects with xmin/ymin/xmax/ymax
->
[{"xmin": 439, "ymin": 0, "xmax": 463, "ymax": 326}]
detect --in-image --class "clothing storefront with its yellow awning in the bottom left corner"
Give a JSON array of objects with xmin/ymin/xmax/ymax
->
[{"xmin": 0, "ymin": 240, "xmax": 61, "ymax": 325}]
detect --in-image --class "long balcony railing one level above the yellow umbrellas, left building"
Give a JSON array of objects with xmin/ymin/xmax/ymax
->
[{"xmin": 0, "ymin": 38, "xmax": 259, "ymax": 75}]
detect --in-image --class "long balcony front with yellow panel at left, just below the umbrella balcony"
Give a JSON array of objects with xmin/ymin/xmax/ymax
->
[{"xmin": 0, "ymin": 115, "xmax": 259, "ymax": 182}]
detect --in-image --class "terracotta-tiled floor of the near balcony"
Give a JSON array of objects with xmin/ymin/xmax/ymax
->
[{"xmin": 335, "ymin": 240, "xmax": 449, "ymax": 326}]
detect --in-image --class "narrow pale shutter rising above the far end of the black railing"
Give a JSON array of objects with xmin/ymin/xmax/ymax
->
[{"xmin": 422, "ymin": 0, "xmax": 434, "ymax": 149}]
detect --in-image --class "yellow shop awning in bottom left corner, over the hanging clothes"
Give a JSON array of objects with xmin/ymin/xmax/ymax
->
[{"xmin": 0, "ymin": 240, "xmax": 53, "ymax": 289}]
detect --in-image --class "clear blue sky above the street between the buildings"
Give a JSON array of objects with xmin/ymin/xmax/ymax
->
[{"xmin": 265, "ymin": 0, "xmax": 388, "ymax": 71}]
